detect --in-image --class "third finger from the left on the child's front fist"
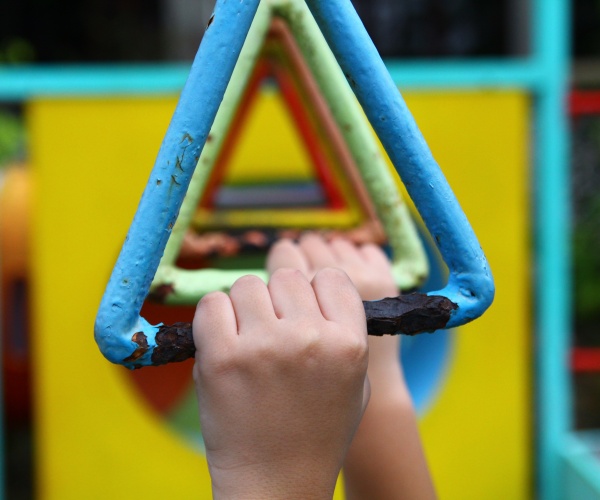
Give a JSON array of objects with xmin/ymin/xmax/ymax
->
[{"xmin": 269, "ymin": 269, "xmax": 320, "ymax": 320}]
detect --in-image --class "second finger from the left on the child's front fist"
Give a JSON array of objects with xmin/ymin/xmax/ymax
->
[{"xmin": 229, "ymin": 275, "xmax": 277, "ymax": 335}]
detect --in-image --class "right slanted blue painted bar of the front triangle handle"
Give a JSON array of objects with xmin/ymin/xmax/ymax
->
[{"xmin": 306, "ymin": 0, "xmax": 495, "ymax": 328}]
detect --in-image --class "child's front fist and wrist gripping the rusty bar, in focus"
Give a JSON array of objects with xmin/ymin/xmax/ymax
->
[{"xmin": 193, "ymin": 269, "xmax": 368, "ymax": 498}]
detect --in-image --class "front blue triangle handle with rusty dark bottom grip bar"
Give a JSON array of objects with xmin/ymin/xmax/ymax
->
[{"xmin": 95, "ymin": 0, "xmax": 494, "ymax": 368}]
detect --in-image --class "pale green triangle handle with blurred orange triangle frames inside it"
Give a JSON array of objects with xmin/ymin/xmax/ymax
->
[{"xmin": 151, "ymin": 1, "xmax": 427, "ymax": 304}]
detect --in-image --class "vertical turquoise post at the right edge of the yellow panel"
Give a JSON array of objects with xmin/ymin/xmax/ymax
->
[{"xmin": 532, "ymin": 0, "xmax": 573, "ymax": 500}]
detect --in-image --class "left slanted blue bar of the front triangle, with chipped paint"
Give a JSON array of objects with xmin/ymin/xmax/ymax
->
[{"xmin": 94, "ymin": 0, "xmax": 259, "ymax": 368}]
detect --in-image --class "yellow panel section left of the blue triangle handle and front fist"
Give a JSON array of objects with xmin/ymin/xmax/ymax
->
[{"xmin": 28, "ymin": 95, "xmax": 210, "ymax": 500}]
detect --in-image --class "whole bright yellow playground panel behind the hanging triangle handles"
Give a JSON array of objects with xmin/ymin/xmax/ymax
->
[{"xmin": 26, "ymin": 90, "xmax": 533, "ymax": 500}]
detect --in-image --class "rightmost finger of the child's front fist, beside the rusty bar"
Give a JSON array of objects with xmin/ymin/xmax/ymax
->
[{"xmin": 312, "ymin": 268, "xmax": 366, "ymax": 326}]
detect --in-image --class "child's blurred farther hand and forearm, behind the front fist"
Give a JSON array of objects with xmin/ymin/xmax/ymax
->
[{"xmin": 267, "ymin": 234, "xmax": 436, "ymax": 500}]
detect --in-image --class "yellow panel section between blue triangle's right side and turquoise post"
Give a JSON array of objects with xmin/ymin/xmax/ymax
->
[{"xmin": 405, "ymin": 91, "xmax": 532, "ymax": 500}]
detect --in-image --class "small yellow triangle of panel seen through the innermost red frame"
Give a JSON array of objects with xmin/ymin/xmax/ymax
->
[{"xmin": 225, "ymin": 91, "xmax": 315, "ymax": 184}]
